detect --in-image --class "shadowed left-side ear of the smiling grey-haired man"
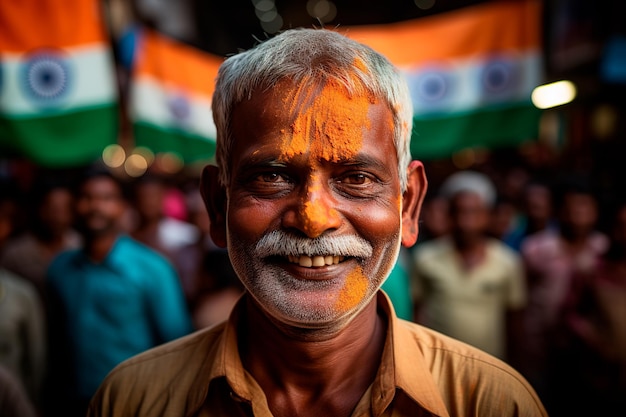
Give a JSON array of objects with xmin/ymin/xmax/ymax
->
[{"xmin": 200, "ymin": 165, "xmax": 227, "ymax": 248}]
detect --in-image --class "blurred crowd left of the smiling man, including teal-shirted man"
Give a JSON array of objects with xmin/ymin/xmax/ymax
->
[{"xmin": 0, "ymin": 162, "xmax": 242, "ymax": 417}]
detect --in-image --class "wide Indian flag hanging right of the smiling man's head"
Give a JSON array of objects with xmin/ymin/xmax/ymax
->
[{"xmin": 344, "ymin": 0, "xmax": 542, "ymax": 159}]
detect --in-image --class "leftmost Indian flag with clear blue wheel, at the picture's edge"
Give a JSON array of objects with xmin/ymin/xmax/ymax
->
[{"xmin": 0, "ymin": 0, "xmax": 118, "ymax": 167}]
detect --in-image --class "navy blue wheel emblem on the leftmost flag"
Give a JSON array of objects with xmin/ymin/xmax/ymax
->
[{"xmin": 21, "ymin": 52, "xmax": 73, "ymax": 106}]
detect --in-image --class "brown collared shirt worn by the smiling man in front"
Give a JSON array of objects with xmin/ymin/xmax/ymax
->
[{"xmin": 88, "ymin": 292, "xmax": 547, "ymax": 417}]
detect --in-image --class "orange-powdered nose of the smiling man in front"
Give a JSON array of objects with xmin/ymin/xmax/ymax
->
[{"xmin": 282, "ymin": 178, "xmax": 341, "ymax": 239}]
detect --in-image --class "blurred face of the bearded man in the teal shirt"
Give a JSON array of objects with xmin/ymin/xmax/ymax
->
[{"xmin": 76, "ymin": 176, "xmax": 126, "ymax": 235}]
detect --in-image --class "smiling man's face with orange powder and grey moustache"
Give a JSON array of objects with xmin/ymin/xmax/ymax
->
[{"xmin": 226, "ymin": 79, "xmax": 402, "ymax": 329}]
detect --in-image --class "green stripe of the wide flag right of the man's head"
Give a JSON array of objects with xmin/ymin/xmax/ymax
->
[{"xmin": 411, "ymin": 104, "xmax": 541, "ymax": 160}]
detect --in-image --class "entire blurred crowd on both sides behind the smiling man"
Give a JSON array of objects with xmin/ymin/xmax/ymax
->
[{"xmin": 0, "ymin": 141, "xmax": 626, "ymax": 416}]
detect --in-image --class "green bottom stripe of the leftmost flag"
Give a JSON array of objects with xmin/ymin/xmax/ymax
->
[{"xmin": 0, "ymin": 104, "xmax": 118, "ymax": 167}]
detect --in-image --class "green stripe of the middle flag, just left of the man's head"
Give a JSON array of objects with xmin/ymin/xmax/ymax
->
[{"xmin": 133, "ymin": 122, "xmax": 215, "ymax": 163}]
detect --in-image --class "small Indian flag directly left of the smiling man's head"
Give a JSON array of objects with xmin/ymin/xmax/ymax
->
[{"xmin": 130, "ymin": 29, "xmax": 223, "ymax": 162}]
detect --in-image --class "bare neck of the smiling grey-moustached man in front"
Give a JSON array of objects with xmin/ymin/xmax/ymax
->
[{"xmin": 240, "ymin": 298, "xmax": 386, "ymax": 416}]
